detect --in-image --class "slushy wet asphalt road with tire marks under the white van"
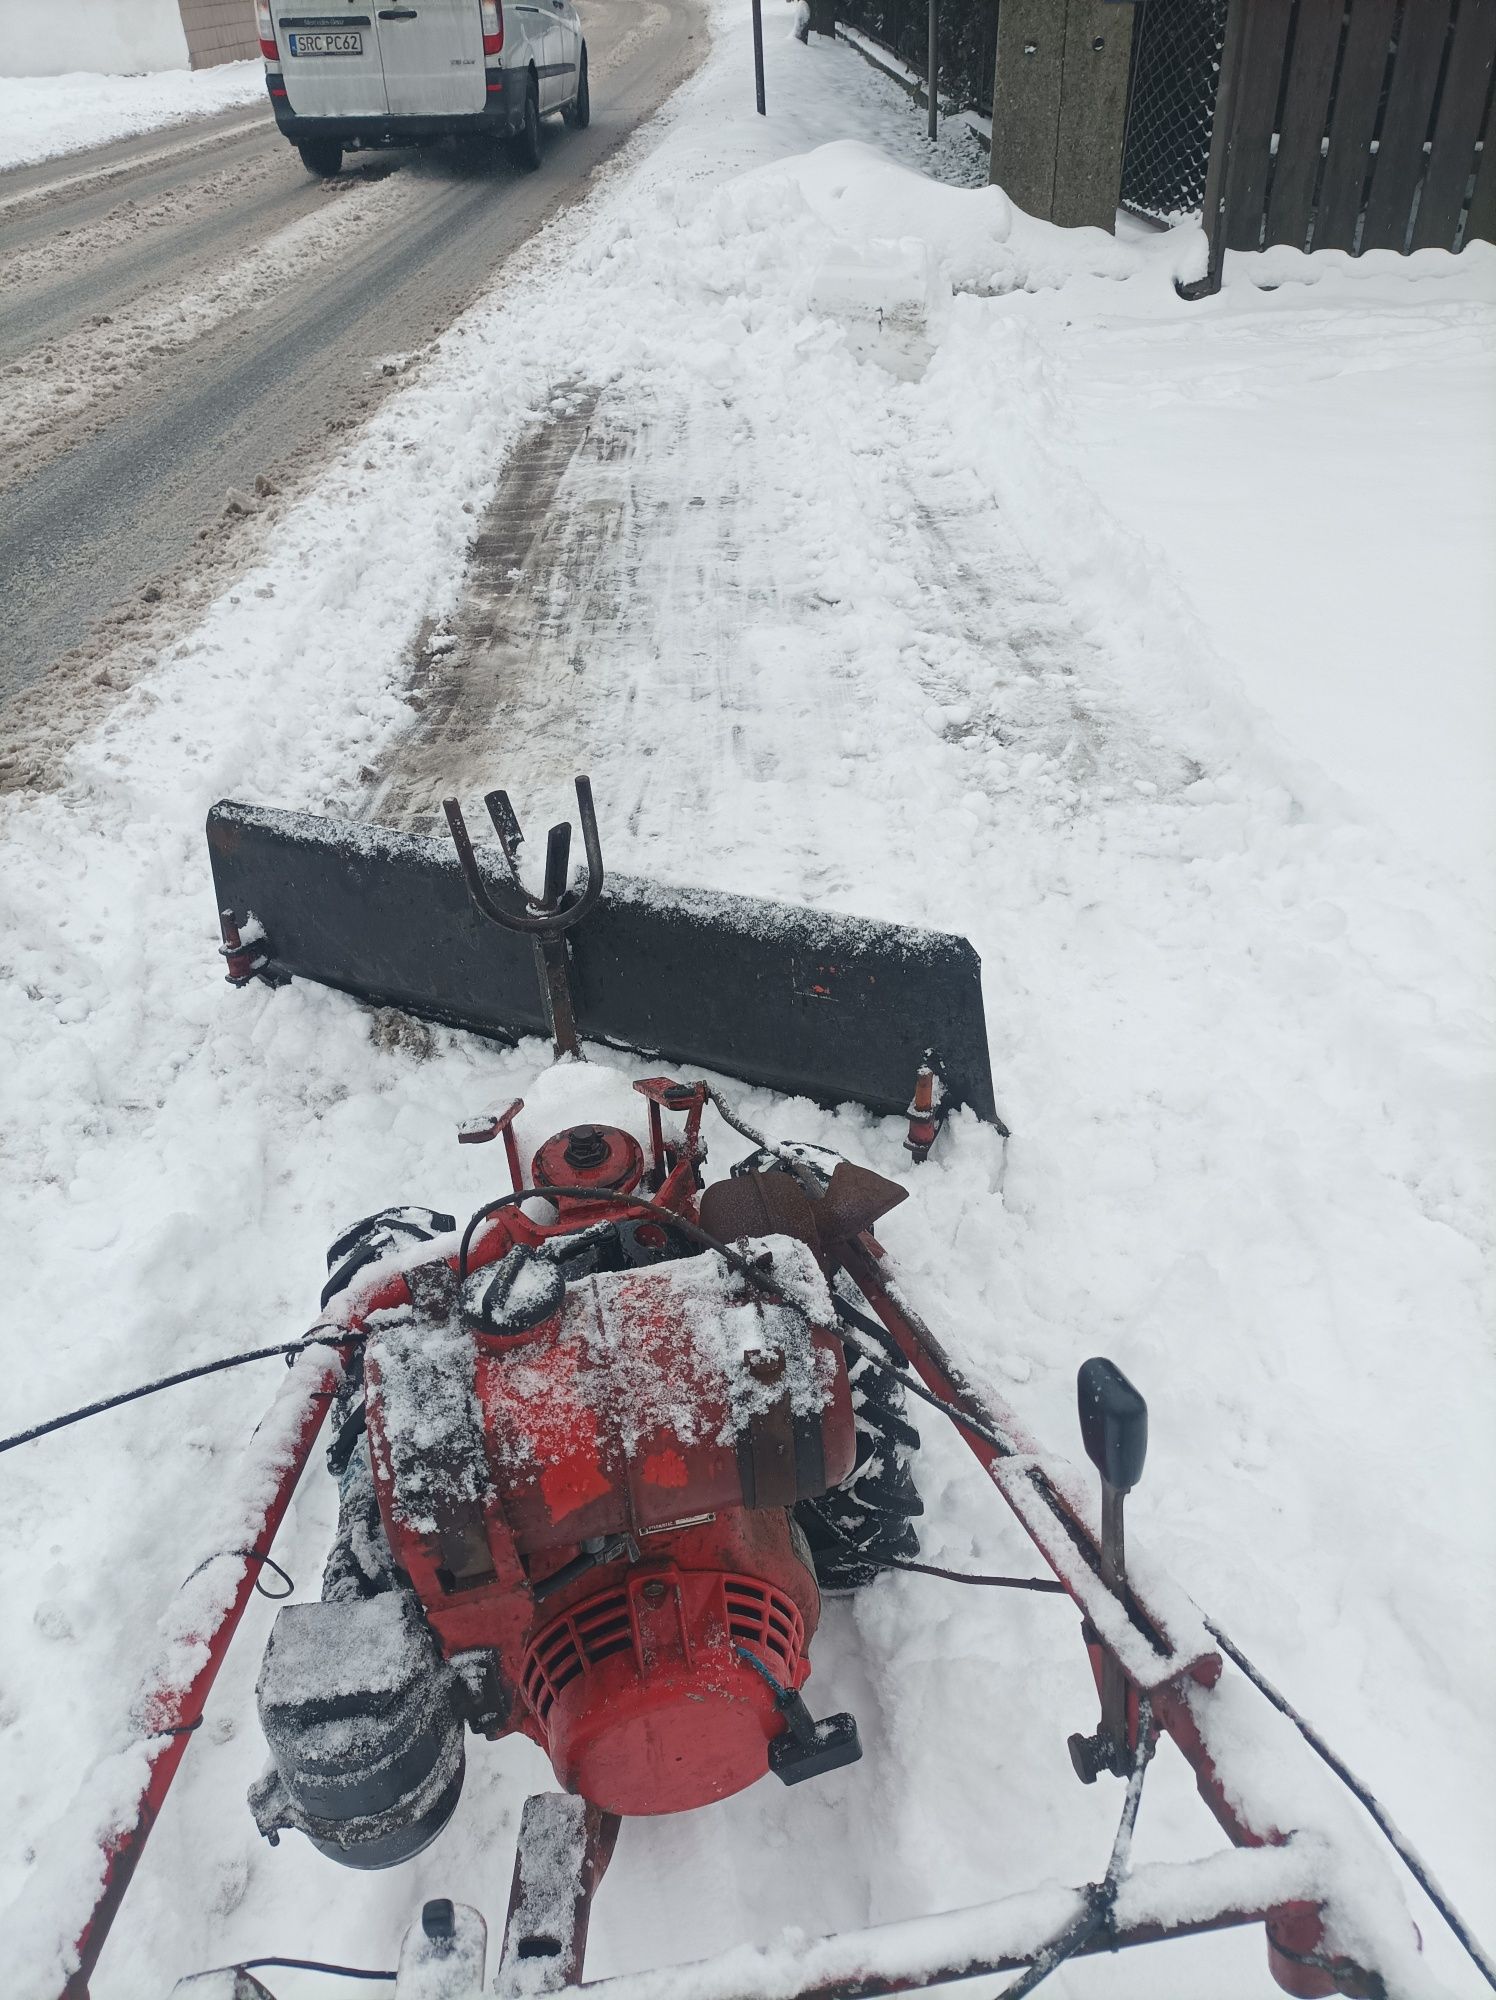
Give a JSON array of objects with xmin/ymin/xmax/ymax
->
[{"xmin": 0, "ymin": 0, "xmax": 706, "ymax": 700}]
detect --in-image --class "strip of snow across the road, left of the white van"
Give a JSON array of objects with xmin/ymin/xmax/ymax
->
[{"xmin": 0, "ymin": 58, "xmax": 264, "ymax": 172}]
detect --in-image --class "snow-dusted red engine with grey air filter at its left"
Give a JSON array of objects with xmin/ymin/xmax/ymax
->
[{"xmin": 252, "ymin": 1078, "xmax": 902, "ymax": 1866}]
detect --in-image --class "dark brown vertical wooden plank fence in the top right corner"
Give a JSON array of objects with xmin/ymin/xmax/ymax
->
[{"xmin": 1204, "ymin": 0, "xmax": 1496, "ymax": 290}]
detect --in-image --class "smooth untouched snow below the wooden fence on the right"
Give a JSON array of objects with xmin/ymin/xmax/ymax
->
[{"xmin": 1052, "ymin": 244, "xmax": 1496, "ymax": 892}]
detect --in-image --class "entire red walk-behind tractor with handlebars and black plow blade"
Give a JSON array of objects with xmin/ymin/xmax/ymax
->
[{"xmin": 4, "ymin": 780, "xmax": 1496, "ymax": 2000}]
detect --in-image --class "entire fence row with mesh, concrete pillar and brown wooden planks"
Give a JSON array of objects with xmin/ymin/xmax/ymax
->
[{"xmin": 824, "ymin": 0, "xmax": 1496, "ymax": 280}]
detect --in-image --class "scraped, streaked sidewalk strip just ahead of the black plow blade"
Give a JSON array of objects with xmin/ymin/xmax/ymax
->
[{"xmin": 364, "ymin": 350, "xmax": 1198, "ymax": 886}]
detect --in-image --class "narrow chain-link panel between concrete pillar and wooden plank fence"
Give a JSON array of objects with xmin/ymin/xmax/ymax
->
[{"xmin": 1122, "ymin": 0, "xmax": 1226, "ymax": 222}]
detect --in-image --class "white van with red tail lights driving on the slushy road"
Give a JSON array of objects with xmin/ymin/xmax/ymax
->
[{"xmin": 256, "ymin": 0, "xmax": 590, "ymax": 174}]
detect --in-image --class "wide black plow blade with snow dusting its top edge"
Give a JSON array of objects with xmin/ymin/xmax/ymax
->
[{"xmin": 208, "ymin": 802, "xmax": 1000, "ymax": 1124}]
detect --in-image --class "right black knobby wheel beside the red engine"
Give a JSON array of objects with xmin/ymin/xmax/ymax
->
[{"xmin": 794, "ymin": 1350, "xmax": 924, "ymax": 1590}]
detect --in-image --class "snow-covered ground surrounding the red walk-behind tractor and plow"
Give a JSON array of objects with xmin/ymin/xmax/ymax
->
[{"xmin": 0, "ymin": 4, "xmax": 1496, "ymax": 2000}]
